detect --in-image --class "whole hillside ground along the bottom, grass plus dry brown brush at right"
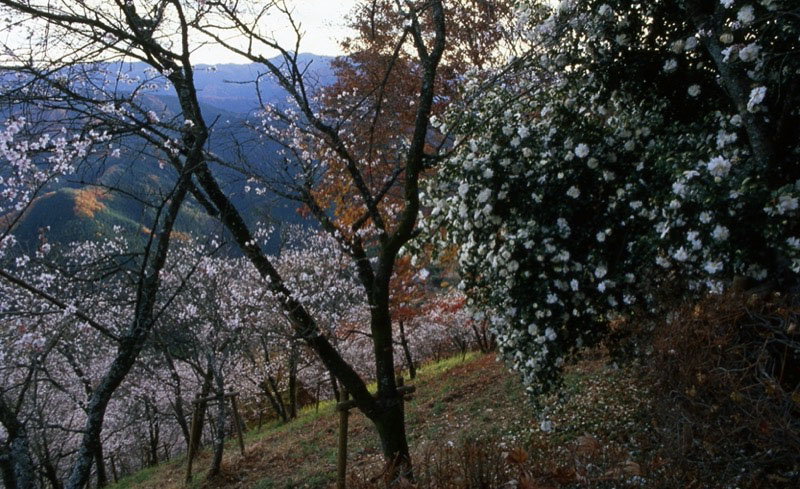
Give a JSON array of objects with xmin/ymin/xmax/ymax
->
[{"xmin": 111, "ymin": 312, "xmax": 800, "ymax": 489}]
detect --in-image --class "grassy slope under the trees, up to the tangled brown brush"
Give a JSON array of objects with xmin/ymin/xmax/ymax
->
[{"xmin": 106, "ymin": 355, "xmax": 655, "ymax": 489}]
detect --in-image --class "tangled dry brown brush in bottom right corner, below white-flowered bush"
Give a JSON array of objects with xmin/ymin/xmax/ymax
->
[{"xmin": 650, "ymin": 293, "xmax": 800, "ymax": 488}]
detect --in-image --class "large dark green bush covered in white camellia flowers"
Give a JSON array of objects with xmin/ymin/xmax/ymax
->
[{"xmin": 425, "ymin": 0, "xmax": 800, "ymax": 394}]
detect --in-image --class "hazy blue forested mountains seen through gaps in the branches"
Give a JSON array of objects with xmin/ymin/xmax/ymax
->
[{"xmin": 5, "ymin": 54, "xmax": 334, "ymax": 250}]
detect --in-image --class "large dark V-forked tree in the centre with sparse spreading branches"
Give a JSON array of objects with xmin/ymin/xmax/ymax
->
[{"xmin": 0, "ymin": 1, "xmax": 445, "ymax": 473}]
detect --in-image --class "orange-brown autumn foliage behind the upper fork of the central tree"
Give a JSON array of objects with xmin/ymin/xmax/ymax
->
[{"xmin": 311, "ymin": 0, "xmax": 513, "ymax": 241}]
